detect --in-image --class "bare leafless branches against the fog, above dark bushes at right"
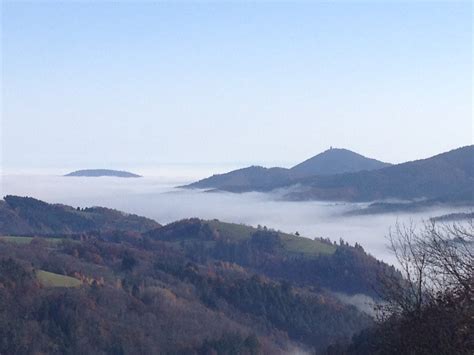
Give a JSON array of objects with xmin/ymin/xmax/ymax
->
[{"xmin": 381, "ymin": 220, "xmax": 474, "ymax": 312}]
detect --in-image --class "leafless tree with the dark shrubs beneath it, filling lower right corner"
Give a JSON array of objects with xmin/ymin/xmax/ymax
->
[{"xmin": 378, "ymin": 220, "xmax": 474, "ymax": 354}]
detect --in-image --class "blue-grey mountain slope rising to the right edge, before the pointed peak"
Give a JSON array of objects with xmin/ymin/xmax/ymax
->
[{"xmin": 287, "ymin": 145, "xmax": 474, "ymax": 204}]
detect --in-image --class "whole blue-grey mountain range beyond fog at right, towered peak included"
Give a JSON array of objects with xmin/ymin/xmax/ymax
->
[{"xmin": 185, "ymin": 145, "xmax": 474, "ymax": 206}]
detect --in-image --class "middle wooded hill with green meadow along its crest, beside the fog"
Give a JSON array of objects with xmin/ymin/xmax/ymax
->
[{"xmin": 145, "ymin": 218, "xmax": 393, "ymax": 296}]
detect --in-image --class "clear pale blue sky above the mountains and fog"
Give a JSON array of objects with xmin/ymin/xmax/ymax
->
[{"xmin": 0, "ymin": 1, "xmax": 473, "ymax": 169}]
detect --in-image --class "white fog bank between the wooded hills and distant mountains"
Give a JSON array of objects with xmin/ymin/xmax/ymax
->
[{"xmin": 0, "ymin": 170, "xmax": 466, "ymax": 264}]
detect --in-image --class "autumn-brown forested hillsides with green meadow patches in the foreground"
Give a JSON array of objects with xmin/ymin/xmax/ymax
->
[{"xmin": 0, "ymin": 197, "xmax": 397, "ymax": 354}]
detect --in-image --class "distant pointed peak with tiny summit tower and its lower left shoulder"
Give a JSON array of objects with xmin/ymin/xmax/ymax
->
[{"xmin": 184, "ymin": 148, "xmax": 390, "ymax": 192}]
